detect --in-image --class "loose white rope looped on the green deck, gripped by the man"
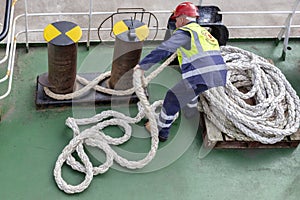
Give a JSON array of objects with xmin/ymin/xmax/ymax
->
[{"xmin": 54, "ymin": 54, "xmax": 176, "ymax": 194}]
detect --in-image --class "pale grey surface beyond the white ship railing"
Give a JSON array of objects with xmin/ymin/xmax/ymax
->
[{"xmin": 0, "ymin": 0, "xmax": 300, "ymax": 42}]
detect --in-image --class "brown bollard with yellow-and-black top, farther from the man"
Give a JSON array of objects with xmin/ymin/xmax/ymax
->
[{"xmin": 39, "ymin": 21, "xmax": 82, "ymax": 94}]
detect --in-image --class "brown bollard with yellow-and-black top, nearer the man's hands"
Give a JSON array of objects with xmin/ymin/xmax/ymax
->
[{"xmin": 108, "ymin": 19, "xmax": 149, "ymax": 90}]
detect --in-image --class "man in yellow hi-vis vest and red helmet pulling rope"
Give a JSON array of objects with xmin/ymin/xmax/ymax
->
[{"xmin": 134, "ymin": 2, "xmax": 227, "ymax": 141}]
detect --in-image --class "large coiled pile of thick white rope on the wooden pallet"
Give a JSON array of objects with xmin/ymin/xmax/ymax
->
[{"xmin": 200, "ymin": 46, "xmax": 300, "ymax": 144}]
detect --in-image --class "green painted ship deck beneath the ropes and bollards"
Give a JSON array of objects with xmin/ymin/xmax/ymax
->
[{"xmin": 0, "ymin": 39, "xmax": 300, "ymax": 200}]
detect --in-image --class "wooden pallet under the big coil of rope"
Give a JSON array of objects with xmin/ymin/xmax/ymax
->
[{"xmin": 202, "ymin": 117, "xmax": 300, "ymax": 149}]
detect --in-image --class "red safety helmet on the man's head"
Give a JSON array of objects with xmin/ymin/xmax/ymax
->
[{"xmin": 171, "ymin": 2, "xmax": 199, "ymax": 19}]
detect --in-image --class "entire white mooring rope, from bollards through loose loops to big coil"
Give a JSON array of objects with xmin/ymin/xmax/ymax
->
[{"xmin": 54, "ymin": 46, "xmax": 299, "ymax": 194}]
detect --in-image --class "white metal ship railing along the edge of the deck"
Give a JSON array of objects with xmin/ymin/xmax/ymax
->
[{"xmin": 0, "ymin": 0, "xmax": 300, "ymax": 99}]
